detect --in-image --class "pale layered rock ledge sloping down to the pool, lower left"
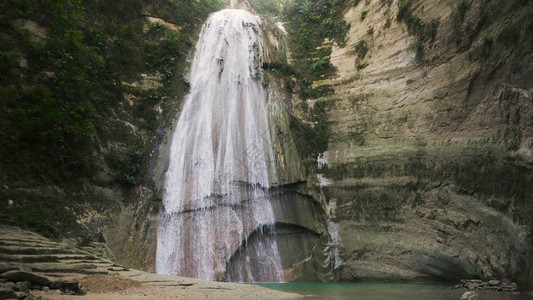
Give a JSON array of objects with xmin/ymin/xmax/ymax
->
[{"xmin": 0, "ymin": 225, "xmax": 300, "ymax": 300}]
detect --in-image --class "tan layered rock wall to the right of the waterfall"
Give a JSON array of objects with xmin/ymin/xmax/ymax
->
[{"xmin": 312, "ymin": 1, "xmax": 533, "ymax": 284}]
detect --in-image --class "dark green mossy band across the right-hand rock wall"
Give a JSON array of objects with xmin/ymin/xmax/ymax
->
[{"xmin": 323, "ymin": 141, "xmax": 533, "ymax": 226}]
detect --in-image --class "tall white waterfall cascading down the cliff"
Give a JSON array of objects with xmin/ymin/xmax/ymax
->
[{"xmin": 156, "ymin": 9, "xmax": 283, "ymax": 282}]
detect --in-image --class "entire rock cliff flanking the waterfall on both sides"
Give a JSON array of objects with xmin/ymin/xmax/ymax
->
[{"xmin": 0, "ymin": 0, "xmax": 533, "ymax": 286}]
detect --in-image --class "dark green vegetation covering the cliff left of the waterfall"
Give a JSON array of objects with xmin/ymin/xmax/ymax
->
[{"xmin": 0, "ymin": 0, "xmax": 222, "ymax": 235}]
